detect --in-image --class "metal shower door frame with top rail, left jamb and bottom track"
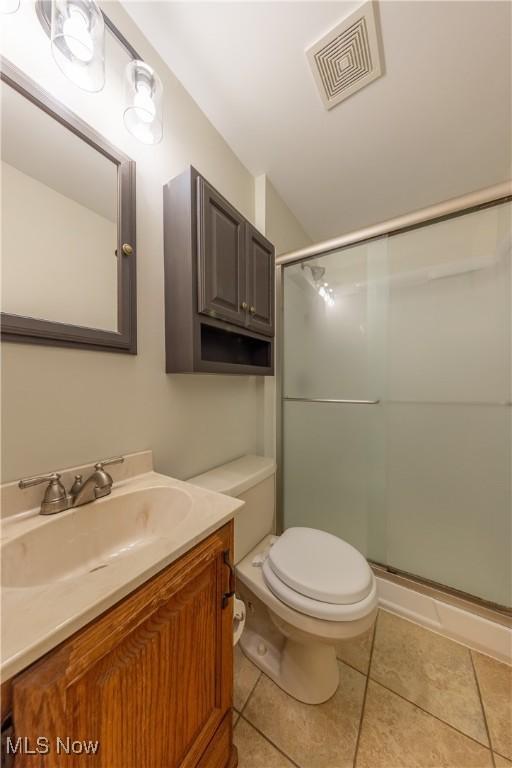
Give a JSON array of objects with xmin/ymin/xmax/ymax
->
[{"xmin": 275, "ymin": 180, "xmax": 512, "ymax": 626}]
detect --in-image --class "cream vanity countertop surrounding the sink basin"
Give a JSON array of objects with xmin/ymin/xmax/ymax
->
[{"xmin": 0, "ymin": 471, "xmax": 243, "ymax": 682}]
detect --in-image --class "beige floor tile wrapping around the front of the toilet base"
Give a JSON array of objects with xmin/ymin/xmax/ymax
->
[{"xmin": 244, "ymin": 663, "xmax": 366, "ymax": 768}]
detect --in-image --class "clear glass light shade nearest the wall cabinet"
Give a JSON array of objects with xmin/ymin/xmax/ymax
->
[{"xmin": 123, "ymin": 59, "xmax": 163, "ymax": 144}]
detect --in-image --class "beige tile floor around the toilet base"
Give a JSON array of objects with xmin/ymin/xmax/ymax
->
[{"xmin": 233, "ymin": 610, "xmax": 512, "ymax": 768}]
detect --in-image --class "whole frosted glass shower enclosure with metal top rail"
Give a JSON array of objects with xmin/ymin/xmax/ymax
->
[{"xmin": 278, "ymin": 186, "xmax": 512, "ymax": 609}]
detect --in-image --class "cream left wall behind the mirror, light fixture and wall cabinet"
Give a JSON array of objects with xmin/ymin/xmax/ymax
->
[{"xmin": 0, "ymin": 3, "xmax": 264, "ymax": 481}]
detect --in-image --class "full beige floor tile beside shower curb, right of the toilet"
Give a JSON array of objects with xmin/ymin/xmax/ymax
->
[{"xmin": 370, "ymin": 611, "xmax": 489, "ymax": 746}]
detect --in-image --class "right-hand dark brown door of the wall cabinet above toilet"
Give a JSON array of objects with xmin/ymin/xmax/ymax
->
[{"xmin": 245, "ymin": 224, "xmax": 275, "ymax": 336}]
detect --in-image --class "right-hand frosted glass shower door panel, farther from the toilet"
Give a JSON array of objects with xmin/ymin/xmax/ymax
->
[{"xmin": 383, "ymin": 203, "xmax": 512, "ymax": 606}]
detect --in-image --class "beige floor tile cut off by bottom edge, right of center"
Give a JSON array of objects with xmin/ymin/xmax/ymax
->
[{"xmin": 356, "ymin": 680, "xmax": 492, "ymax": 768}]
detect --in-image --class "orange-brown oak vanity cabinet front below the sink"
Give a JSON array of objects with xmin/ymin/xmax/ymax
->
[{"xmin": 13, "ymin": 525, "xmax": 233, "ymax": 768}]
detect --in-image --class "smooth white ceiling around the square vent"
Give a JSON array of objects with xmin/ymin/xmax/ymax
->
[{"xmin": 125, "ymin": 0, "xmax": 512, "ymax": 241}]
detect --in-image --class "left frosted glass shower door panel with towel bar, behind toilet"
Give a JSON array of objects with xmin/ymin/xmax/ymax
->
[{"xmin": 283, "ymin": 238, "xmax": 387, "ymax": 560}]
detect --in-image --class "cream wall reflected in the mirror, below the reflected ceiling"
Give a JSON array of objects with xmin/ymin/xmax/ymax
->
[{"xmin": 1, "ymin": 161, "xmax": 117, "ymax": 331}]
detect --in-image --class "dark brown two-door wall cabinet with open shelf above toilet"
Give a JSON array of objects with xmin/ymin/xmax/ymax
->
[{"xmin": 164, "ymin": 168, "xmax": 275, "ymax": 375}]
